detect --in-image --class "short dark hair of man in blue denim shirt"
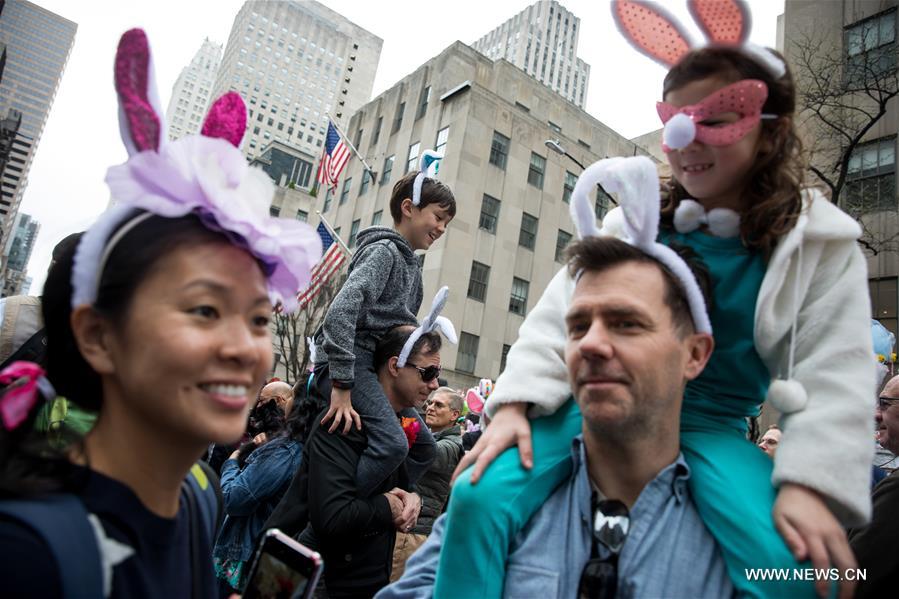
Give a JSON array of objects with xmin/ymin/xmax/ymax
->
[{"xmin": 567, "ymin": 237, "xmax": 712, "ymax": 335}]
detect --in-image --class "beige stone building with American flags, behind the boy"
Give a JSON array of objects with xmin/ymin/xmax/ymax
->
[{"xmin": 316, "ymin": 42, "xmax": 648, "ymax": 386}]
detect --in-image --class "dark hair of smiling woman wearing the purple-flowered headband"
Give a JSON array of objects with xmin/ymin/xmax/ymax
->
[{"xmin": 0, "ymin": 212, "xmax": 243, "ymax": 496}]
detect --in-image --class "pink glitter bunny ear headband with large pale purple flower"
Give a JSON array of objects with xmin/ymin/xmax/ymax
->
[{"xmin": 72, "ymin": 29, "xmax": 321, "ymax": 311}]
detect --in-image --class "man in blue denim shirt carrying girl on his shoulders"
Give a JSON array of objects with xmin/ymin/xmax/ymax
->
[{"xmin": 378, "ymin": 237, "xmax": 734, "ymax": 599}]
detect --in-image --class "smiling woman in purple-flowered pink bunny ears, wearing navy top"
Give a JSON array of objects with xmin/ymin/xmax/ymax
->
[{"xmin": 0, "ymin": 30, "xmax": 321, "ymax": 598}]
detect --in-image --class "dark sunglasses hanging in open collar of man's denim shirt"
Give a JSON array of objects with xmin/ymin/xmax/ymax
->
[{"xmin": 578, "ymin": 499, "xmax": 630, "ymax": 599}]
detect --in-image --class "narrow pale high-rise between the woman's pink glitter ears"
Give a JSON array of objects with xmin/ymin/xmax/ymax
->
[{"xmin": 165, "ymin": 38, "xmax": 222, "ymax": 141}]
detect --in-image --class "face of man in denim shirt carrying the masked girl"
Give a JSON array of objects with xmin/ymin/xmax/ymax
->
[{"xmin": 565, "ymin": 262, "xmax": 711, "ymax": 432}]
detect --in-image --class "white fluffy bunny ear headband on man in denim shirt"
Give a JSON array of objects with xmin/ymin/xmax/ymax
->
[{"xmin": 571, "ymin": 156, "xmax": 712, "ymax": 334}]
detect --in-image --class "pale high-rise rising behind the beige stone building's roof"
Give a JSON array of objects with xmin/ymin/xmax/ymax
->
[{"xmin": 472, "ymin": 0, "xmax": 590, "ymax": 108}]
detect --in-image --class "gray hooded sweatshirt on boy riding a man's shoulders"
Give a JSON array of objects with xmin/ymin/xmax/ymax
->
[{"xmin": 315, "ymin": 227, "xmax": 422, "ymax": 381}]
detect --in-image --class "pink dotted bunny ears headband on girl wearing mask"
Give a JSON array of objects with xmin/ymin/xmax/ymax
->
[{"xmin": 612, "ymin": 0, "xmax": 786, "ymax": 78}]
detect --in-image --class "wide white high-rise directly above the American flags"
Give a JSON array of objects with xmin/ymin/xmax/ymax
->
[{"xmin": 213, "ymin": 0, "xmax": 383, "ymax": 169}]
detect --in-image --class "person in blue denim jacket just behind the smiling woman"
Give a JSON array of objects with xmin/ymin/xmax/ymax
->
[{"xmin": 213, "ymin": 392, "xmax": 309, "ymax": 593}]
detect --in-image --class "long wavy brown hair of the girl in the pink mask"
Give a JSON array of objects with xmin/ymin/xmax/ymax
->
[{"xmin": 662, "ymin": 47, "xmax": 805, "ymax": 258}]
